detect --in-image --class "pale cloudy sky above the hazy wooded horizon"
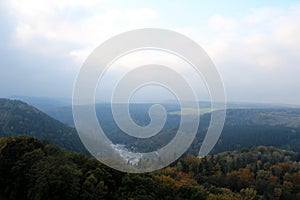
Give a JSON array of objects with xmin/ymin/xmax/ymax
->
[{"xmin": 0, "ymin": 0, "xmax": 300, "ymax": 104}]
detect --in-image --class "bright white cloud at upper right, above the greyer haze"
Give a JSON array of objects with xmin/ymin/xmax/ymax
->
[{"xmin": 207, "ymin": 4, "xmax": 300, "ymax": 69}]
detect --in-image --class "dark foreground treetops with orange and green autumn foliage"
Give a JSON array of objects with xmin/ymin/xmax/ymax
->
[{"xmin": 0, "ymin": 136, "xmax": 300, "ymax": 200}]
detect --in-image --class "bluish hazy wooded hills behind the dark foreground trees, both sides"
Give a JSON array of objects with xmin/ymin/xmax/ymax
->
[{"xmin": 0, "ymin": 98, "xmax": 300, "ymax": 155}]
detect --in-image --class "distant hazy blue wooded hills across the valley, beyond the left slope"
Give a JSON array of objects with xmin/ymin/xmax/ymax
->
[{"xmin": 42, "ymin": 104, "xmax": 300, "ymax": 155}]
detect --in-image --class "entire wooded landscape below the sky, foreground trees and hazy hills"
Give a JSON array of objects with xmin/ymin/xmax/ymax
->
[{"xmin": 0, "ymin": 99, "xmax": 300, "ymax": 200}]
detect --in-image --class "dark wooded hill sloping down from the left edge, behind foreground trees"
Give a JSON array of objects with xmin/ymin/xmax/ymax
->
[{"xmin": 0, "ymin": 99, "xmax": 86, "ymax": 152}]
